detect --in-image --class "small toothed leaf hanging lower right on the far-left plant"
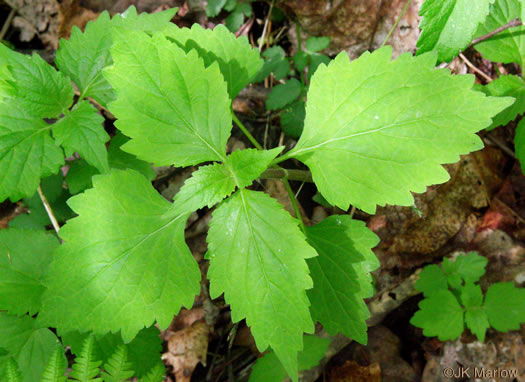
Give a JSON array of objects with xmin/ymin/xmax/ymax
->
[{"xmin": 53, "ymin": 101, "xmax": 109, "ymax": 173}]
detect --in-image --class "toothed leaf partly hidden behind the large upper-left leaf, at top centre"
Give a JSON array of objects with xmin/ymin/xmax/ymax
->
[{"xmin": 164, "ymin": 24, "xmax": 262, "ymax": 101}]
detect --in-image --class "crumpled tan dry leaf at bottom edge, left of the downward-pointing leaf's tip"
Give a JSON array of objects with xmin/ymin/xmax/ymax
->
[{"xmin": 162, "ymin": 322, "xmax": 210, "ymax": 382}]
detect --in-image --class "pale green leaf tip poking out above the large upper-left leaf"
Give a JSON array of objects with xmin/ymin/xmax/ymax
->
[{"xmin": 111, "ymin": 5, "xmax": 178, "ymax": 32}]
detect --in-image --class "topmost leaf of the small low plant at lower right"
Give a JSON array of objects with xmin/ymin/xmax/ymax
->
[{"xmin": 443, "ymin": 252, "xmax": 488, "ymax": 289}]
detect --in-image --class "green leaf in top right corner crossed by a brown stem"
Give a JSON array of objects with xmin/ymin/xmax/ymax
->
[{"xmin": 475, "ymin": 0, "xmax": 525, "ymax": 67}]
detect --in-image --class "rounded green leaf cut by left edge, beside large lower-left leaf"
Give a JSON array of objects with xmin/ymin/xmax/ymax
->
[{"xmin": 0, "ymin": 228, "xmax": 59, "ymax": 314}]
